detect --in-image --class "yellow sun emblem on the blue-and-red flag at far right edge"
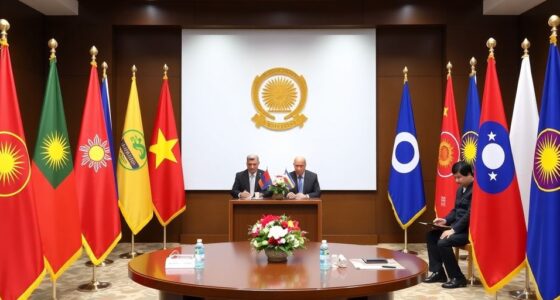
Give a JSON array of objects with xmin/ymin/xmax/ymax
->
[{"xmin": 533, "ymin": 128, "xmax": 560, "ymax": 192}]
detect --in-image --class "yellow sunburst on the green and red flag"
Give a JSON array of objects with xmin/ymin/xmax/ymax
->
[{"xmin": 41, "ymin": 131, "xmax": 70, "ymax": 170}]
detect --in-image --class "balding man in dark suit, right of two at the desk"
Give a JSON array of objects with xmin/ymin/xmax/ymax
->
[{"xmin": 287, "ymin": 156, "xmax": 321, "ymax": 199}]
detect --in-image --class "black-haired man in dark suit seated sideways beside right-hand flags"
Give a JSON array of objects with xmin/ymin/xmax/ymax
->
[{"xmin": 424, "ymin": 161, "xmax": 474, "ymax": 289}]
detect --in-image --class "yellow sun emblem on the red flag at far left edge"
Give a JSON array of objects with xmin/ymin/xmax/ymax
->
[{"xmin": 0, "ymin": 131, "xmax": 31, "ymax": 197}]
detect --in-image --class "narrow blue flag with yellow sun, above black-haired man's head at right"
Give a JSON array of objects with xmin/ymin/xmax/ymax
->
[{"xmin": 461, "ymin": 74, "xmax": 480, "ymax": 167}]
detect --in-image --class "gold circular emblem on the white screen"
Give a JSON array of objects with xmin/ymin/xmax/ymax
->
[{"xmin": 251, "ymin": 68, "xmax": 307, "ymax": 130}]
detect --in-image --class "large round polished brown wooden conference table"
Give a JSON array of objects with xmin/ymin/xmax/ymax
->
[{"xmin": 128, "ymin": 241, "xmax": 428, "ymax": 300}]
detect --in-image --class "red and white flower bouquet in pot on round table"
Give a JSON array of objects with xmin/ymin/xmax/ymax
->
[{"xmin": 249, "ymin": 215, "xmax": 307, "ymax": 262}]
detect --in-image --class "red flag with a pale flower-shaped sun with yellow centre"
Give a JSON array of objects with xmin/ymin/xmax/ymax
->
[{"xmin": 74, "ymin": 52, "xmax": 121, "ymax": 265}]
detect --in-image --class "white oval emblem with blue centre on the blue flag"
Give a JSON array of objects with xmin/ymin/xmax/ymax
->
[{"xmin": 391, "ymin": 132, "xmax": 420, "ymax": 174}]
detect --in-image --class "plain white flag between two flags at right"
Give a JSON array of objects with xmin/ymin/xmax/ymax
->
[{"xmin": 509, "ymin": 55, "xmax": 539, "ymax": 226}]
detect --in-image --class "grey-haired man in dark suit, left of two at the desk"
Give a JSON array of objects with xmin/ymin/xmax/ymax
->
[{"xmin": 231, "ymin": 154, "xmax": 267, "ymax": 199}]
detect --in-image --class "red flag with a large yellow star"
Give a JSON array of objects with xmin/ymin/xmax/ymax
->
[{"xmin": 148, "ymin": 71, "xmax": 185, "ymax": 226}]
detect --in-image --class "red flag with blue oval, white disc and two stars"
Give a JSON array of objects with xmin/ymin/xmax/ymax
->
[{"xmin": 469, "ymin": 48, "xmax": 527, "ymax": 293}]
